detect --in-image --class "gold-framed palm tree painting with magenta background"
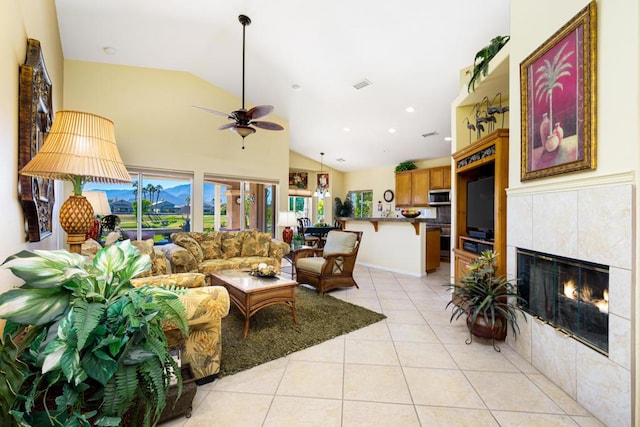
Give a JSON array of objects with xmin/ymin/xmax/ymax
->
[{"xmin": 520, "ymin": 1, "xmax": 597, "ymax": 181}]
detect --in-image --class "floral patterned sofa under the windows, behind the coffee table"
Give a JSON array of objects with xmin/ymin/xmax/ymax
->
[{"xmin": 168, "ymin": 230, "xmax": 290, "ymax": 280}]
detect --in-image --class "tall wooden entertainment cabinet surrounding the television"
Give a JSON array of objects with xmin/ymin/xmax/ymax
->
[{"xmin": 452, "ymin": 129, "xmax": 509, "ymax": 280}]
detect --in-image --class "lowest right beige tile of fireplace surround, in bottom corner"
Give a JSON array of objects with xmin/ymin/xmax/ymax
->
[{"xmin": 576, "ymin": 345, "xmax": 631, "ymax": 427}]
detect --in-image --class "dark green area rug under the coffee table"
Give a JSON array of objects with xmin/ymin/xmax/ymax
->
[{"xmin": 218, "ymin": 286, "xmax": 386, "ymax": 377}]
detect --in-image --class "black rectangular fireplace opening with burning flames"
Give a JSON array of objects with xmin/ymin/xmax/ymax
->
[{"xmin": 516, "ymin": 249, "xmax": 609, "ymax": 354}]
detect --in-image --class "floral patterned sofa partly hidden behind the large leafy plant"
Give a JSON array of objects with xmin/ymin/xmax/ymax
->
[{"xmin": 82, "ymin": 239, "xmax": 229, "ymax": 384}]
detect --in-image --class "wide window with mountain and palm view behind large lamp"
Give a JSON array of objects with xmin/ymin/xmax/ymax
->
[{"xmin": 85, "ymin": 169, "xmax": 192, "ymax": 244}]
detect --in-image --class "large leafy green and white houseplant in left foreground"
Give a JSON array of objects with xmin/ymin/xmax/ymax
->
[{"xmin": 0, "ymin": 240, "xmax": 188, "ymax": 426}]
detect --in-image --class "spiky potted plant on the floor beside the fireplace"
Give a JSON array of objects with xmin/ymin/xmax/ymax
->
[{"xmin": 445, "ymin": 251, "xmax": 527, "ymax": 351}]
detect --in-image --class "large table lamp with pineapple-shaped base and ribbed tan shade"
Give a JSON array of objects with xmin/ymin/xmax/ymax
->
[{"xmin": 20, "ymin": 111, "xmax": 131, "ymax": 253}]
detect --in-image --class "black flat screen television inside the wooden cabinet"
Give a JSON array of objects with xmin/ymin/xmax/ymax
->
[{"xmin": 467, "ymin": 176, "xmax": 494, "ymax": 239}]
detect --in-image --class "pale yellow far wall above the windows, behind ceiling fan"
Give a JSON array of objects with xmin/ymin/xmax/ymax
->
[{"xmin": 64, "ymin": 60, "xmax": 289, "ymax": 230}]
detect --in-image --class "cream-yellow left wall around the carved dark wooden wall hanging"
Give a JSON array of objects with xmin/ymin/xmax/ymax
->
[{"xmin": 0, "ymin": 0, "xmax": 64, "ymax": 292}]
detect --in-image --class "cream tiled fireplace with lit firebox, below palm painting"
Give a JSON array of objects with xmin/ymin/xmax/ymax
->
[{"xmin": 507, "ymin": 181, "xmax": 635, "ymax": 426}]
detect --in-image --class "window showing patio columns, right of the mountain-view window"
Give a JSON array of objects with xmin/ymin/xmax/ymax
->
[{"xmin": 203, "ymin": 176, "xmax": 276, "ymax": 234}]
